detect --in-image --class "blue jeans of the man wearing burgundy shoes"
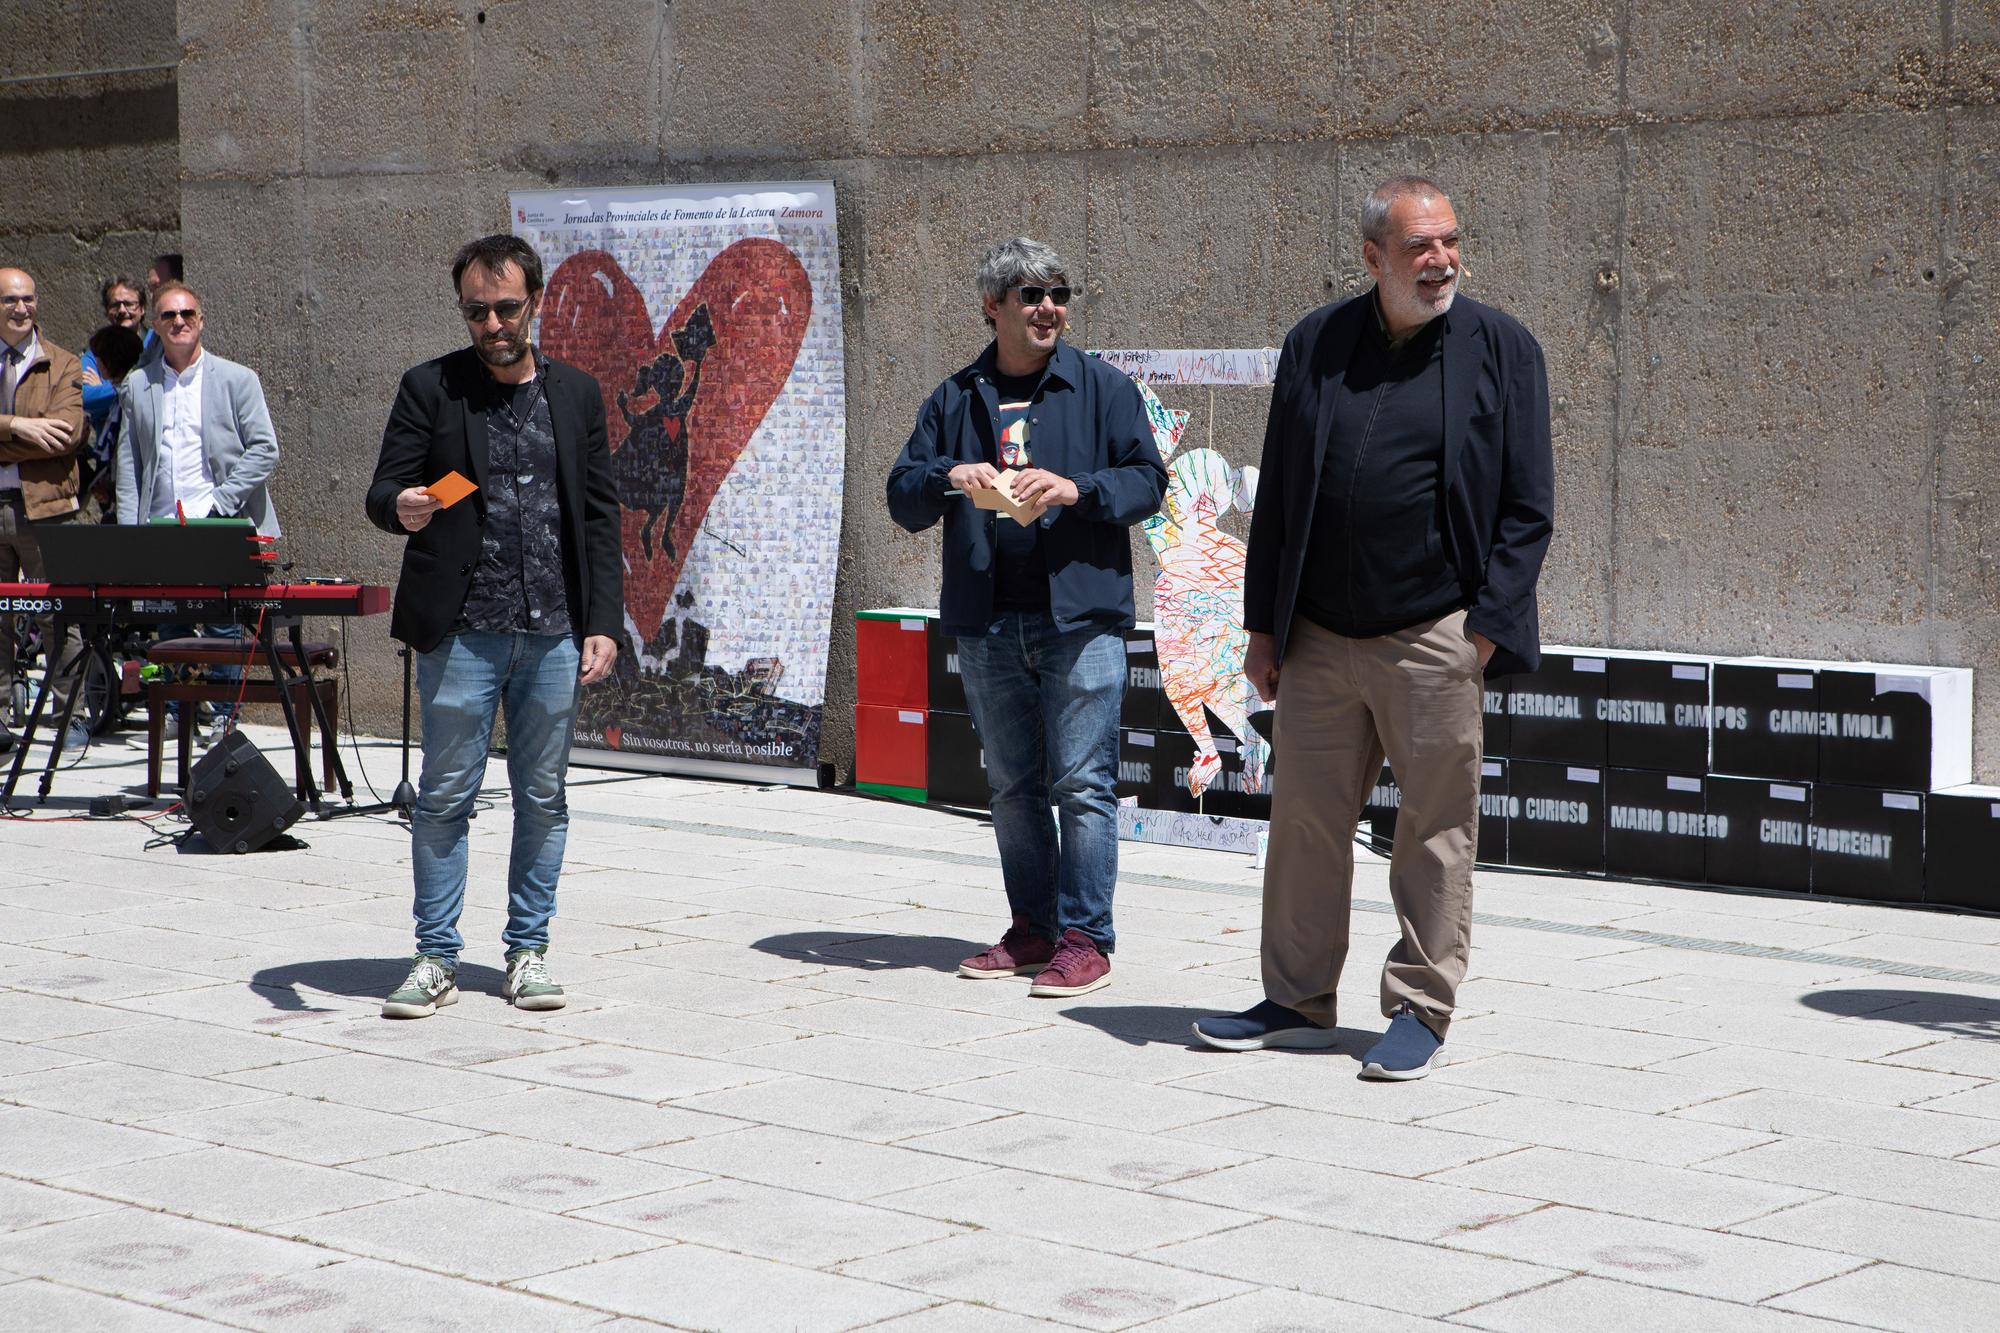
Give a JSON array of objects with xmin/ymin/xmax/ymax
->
[{"xmin": 958, "ymin": 610, "xmax": 1126, "ymax": 953}]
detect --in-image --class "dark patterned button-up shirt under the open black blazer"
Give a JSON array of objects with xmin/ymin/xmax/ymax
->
[{"xmin": 460, "ymin": 356, "xmax": 570, "ymax": 634}]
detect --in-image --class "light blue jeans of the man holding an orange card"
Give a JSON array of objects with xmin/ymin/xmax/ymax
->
[{"xmin": 410, "ymin": 630, "xmax": 578, "ymax": 959}]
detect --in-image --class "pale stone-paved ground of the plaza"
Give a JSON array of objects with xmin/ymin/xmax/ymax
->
[{"xmin": 0, "ymin": 729, "xmax": 2000, "ymax": 1333}]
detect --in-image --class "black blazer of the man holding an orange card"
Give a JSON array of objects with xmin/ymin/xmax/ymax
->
[{"xmin": 368, "ymin": 346, "xmax": 626, "ymax": 652}]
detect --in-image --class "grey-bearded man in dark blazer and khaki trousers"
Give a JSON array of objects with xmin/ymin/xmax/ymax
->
[{"xmin": 1194, "ymin": 176, "xmax": 1554, "ymax": 1079}]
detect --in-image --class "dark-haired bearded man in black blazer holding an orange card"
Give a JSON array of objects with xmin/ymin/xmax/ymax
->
[{"xmin": 368, "ymin": 236, "xmax": 624, "ymax": 1019}]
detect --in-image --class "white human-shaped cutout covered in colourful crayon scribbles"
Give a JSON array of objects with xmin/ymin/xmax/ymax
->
[{"xmin": 1138, "ymin": 382, "xmax": 1270, "ymax": 797}]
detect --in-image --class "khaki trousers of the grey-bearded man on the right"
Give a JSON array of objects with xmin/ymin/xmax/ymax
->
[{"xmin": 1262, "ymin": 610, "xmax": 1484, "ymax": 1037}]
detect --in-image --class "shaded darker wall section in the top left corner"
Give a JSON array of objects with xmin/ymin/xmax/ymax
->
[{"xmin": 0, "ymin": 0, "xmax": 180, "ymax": 352}]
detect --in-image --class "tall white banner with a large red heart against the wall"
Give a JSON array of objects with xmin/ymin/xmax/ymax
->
[{"xmin": 508, "ymin": 180, "xmax": 846, "ymax": 783}]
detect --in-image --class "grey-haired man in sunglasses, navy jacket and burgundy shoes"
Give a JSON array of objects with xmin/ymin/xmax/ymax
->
[{"xmin": 888, "ymin": 236, "xmax": 1166, "ymax": 997}]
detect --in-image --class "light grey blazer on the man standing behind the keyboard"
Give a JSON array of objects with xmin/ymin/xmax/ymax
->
[{"xmin": 116, "ymin": 350, "xmax": 278, "ymax": 536}]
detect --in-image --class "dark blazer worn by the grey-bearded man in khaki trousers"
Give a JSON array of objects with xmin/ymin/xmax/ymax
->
[{"xmin": 1244, "ymin": 290, "xmax": 1556, "ymax": 677}]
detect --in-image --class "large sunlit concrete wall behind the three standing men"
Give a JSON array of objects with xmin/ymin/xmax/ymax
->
[{"xmin": 160, "ymin": 0, "xmax": 2000, "ymax": 781}]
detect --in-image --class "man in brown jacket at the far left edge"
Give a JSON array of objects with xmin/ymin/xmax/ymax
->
[{"xmin": 0, "ymin": 268, "xmax": 90, "ymax": 755}]
